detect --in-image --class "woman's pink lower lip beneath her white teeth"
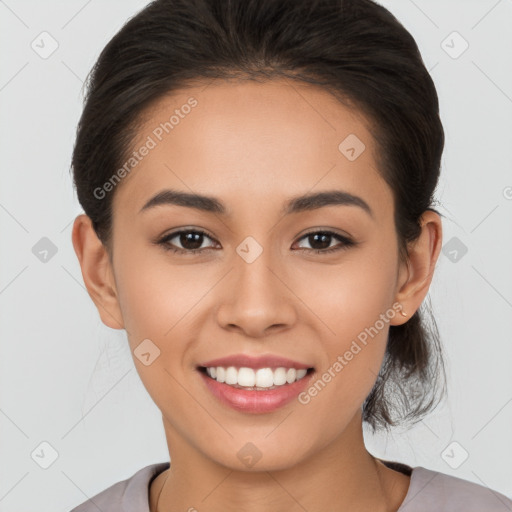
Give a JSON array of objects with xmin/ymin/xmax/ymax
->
[{"xmin": 199, "ymin": 371, "xmax": 315, "ymax": 414}]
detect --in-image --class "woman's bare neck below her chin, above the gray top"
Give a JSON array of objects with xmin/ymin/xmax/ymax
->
[{"xmin": 150, "ymin": 413, "xmax": 410, "ymax": 512}]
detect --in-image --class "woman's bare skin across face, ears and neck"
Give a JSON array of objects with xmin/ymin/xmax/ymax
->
[{"xmin": 72, "ymin": 80, "xmax": 442, "ymax": 512}]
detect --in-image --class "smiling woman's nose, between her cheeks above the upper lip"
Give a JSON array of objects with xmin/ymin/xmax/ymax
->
[{"xmin": 217, "ymin": 246, "xmax": 298, "ymax": 338}]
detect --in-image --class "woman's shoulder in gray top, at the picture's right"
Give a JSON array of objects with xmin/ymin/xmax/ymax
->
[{"xmin": 397, "ymin": 466, "xmax": 512, "ymax": 512}]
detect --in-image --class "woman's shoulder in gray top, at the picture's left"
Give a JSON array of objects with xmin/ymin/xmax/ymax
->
[{"xmin": 71, "ymin": 462, "xmax": 169, "ymax": 512}]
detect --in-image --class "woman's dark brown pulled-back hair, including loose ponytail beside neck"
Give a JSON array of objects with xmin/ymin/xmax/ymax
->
[{"xmin": 72, "ymin": 0, "xmax": 446, "ymax": 431}]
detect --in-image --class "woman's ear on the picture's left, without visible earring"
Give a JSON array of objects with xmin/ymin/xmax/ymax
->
[{"xmin": 72, "ymin": 214, "xmax": 124, "ymax": 329}]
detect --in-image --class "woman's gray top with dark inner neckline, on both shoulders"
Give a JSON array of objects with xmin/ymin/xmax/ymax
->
[{"xmin": 71, "ymin": 459, "xmax": 512, "ymax": 512}]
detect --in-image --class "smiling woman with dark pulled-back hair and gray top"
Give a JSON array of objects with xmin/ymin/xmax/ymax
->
[{"xmin": 72, "ymin": 0, "xmax": 512, "ymax": 512}]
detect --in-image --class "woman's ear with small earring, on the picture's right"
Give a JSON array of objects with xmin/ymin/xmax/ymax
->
[{"xmin": 391, "ymin": 210, "xmax": 442, "ymax": 325}]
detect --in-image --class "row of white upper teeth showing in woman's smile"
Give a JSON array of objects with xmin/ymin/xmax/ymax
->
[{"xmin": 206, "ymin": 366, "xmax": 307, "ymax": 389}]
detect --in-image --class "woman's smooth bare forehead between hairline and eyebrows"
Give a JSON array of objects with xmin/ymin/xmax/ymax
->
[{"xmin": 114, "ymin": 80, "xmax": 389, "ymax": 217}]
